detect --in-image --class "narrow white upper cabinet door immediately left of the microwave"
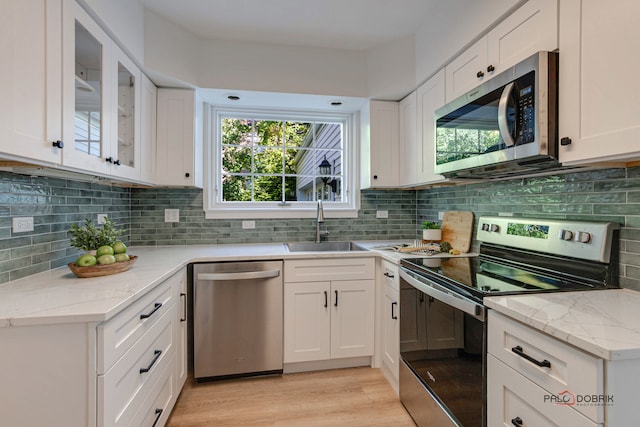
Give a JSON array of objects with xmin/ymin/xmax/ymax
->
[{"xmin": 413, "ymin": 69, "xmax": 445, "ymax": 184}]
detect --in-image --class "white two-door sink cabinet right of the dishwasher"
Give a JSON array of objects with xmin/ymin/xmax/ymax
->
[{"xmin": 284, "ymin": 258, "xmax": 375, "ymax": 363}]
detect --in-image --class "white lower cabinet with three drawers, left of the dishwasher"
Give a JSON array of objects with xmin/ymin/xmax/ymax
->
[{"xmin": 0, "ymin": 269, "xmax": 187, "ymax": 427}]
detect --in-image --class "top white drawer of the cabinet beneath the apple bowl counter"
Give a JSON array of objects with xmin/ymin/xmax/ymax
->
[{"xmin": 98, "ymin": 276, "xmax": 177, "ymax": 375}]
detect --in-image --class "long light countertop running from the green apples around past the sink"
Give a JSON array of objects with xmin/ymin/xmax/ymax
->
[{"xmin": 0, "ymin": 241, "xmax": 464, "ymax": 327}]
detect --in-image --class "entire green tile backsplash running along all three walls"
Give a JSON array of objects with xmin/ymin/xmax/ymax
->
[{"xmin": 0, "ymin": 168, "xmax": 640, "ymax": 290}]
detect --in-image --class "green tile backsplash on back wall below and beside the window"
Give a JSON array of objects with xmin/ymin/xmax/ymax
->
[{"xmin": 131, "ymin": 189, "xmax": 416, "ymax": 246}]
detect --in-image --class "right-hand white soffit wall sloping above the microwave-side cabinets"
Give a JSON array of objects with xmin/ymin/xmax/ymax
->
[{"xmin": 415, "ymin": 0, "xmax": 526, "ymax": 86}]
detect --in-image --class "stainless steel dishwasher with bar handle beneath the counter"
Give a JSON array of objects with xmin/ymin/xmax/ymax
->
[{"xmin": 193, "ymin": 261, "xmax": 283, "ymax": 379}]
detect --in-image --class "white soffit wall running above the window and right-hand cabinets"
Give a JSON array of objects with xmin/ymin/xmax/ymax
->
[{"xmin": 141, "ymin": 0, "xmax": 526, "ymax": 100}]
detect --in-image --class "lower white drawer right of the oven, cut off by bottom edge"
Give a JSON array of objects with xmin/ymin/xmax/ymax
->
[{"xmin": 487, "ymin": 355, "xmax": 598, "ymax": 427}]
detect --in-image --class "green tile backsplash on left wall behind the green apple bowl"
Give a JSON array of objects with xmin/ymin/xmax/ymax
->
[{"xmin": 0, "ymin": 172, "xmax": 131, "ymax": 283}]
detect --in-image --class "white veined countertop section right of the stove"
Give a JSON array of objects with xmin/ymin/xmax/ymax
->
[{"xmin": 484, "ymin": 289, "xmax": 640, "ymax": 360}]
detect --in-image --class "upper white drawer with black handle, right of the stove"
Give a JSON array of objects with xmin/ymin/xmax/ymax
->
[{"xmin": 487, "ymin": 310, "xmax": 604, "ymax": 422}]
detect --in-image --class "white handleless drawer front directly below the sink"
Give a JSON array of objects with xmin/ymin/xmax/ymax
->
[{"xmin": 284, "ymin": 257, "xmax": 375, "ymax": 283}]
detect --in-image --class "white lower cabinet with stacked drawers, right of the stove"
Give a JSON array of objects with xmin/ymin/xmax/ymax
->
[{"xmin": 487, "ymin": 311, "xmax": 613, "ymax": 426}]
